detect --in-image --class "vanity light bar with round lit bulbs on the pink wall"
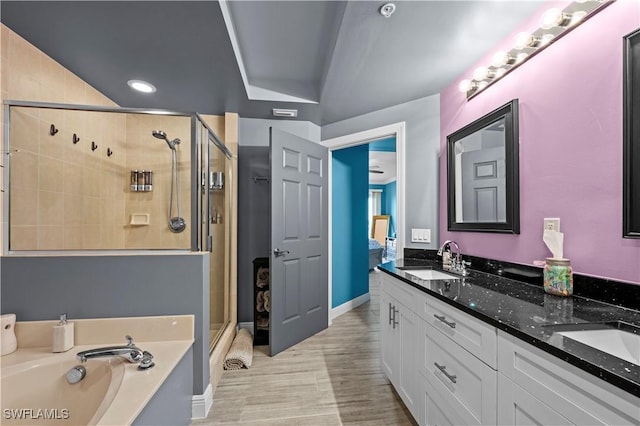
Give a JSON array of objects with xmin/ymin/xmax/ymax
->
[{"xmin": 458, "ymin": 0, "xmax": 615, "ymax": 100}]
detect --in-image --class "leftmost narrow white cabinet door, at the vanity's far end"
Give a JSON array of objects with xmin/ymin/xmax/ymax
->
[{"xmin": 380, "ymin": 291, "xmax": 400, "ymax": 382}]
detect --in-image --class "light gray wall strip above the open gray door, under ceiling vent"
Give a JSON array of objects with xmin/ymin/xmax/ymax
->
[{"xmin": 238, "ymin": 118, "xmax": 320, "ymax": 146}]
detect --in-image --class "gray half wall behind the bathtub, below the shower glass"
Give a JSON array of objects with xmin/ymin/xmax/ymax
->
[{"xmin": 0, "ymin": 253, "xmax": 210, "ymax": 395}]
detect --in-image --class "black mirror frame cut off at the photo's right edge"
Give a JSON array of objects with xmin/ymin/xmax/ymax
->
[{"xmin": 622, "ymin": 29, "xmax": 640, "ymax": 238}]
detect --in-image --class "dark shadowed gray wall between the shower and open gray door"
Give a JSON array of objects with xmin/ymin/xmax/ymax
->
[{"xmin": 238, "ymin": 146, "xmax": 271, "ymax": 322}]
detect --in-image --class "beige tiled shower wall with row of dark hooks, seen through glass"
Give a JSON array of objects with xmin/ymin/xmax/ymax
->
[{"xmin": 9, "ymin": 108, "xmax": 128, "ymax": 250}]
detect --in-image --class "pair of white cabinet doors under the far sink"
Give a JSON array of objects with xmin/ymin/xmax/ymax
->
[{"xmin": 380, "ymin": 278, "xmax": 419, "ymax": 417}]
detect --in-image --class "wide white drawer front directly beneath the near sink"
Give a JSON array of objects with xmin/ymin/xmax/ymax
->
[{"xmin": 498, "ymin": 332, "xmax": 640, "ymax": 425}]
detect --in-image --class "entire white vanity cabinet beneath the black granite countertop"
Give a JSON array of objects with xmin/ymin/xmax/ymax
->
[{"xmin": 380, "ymin": 274, "xmax": 640, "ymax": 426}]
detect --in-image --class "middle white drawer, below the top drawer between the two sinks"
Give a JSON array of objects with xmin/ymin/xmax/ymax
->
[{"xmin": 420, "ymin": 325, "xmax": 497, "ymax": 425}]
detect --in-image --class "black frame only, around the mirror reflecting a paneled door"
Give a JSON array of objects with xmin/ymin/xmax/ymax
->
[{"xmin": 447, "ymin": 99, "xmax": 520, "ymax": 234}]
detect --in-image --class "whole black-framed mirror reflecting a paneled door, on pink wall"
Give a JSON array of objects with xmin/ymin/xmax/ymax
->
[{"xmin": 447, "ymin": 99, "xmax": 520, "ymax": 234}]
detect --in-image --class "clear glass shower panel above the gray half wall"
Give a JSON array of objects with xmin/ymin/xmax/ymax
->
[{"xmin": 6, "ymin": 105, "xmax": 192, "ymax": 251}]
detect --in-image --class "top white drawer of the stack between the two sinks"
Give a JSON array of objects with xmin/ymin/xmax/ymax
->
[{"xmin": 421, "ymin": 297, "xmax": 498, "ymax": 369}]
